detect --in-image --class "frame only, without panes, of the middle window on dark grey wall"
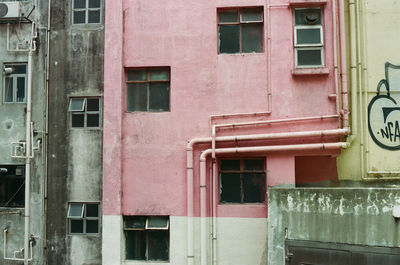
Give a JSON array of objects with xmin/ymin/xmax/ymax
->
[{"xmin": 68, "ymin": 96, "xmax": 103, "ymax": 130}]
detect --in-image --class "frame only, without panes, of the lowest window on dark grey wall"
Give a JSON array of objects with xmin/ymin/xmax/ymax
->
[{"xmin": 67, "ymin": 202, "xmax": 101, "ymax": 233}]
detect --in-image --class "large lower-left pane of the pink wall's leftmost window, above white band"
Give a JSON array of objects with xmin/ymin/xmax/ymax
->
[{"xmin": 126, "ymin": 83, "xmax": 147, "ymax": 111}]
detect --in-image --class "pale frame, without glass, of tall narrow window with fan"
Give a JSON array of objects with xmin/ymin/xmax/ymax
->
[{"xmin": 293, "ymin": 6, "xmax": 325, "ymax": 69}]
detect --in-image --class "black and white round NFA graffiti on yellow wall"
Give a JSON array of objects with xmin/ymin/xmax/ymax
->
[{"xmin": 368, "ymin": 63, "xmax": 400, "ymax": 148}]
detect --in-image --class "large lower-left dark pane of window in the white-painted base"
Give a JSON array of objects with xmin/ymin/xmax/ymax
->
[{"xmin": 125, "ymin": 231, "xmax": 146, "ymax": 260}]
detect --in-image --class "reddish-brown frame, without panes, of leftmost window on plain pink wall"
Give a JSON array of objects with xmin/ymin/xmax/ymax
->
[{"xmin": 125, "ymin": 66, "xmax": 171, "ymax": 113}]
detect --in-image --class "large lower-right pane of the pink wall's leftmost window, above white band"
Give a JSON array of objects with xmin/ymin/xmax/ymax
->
[{"xmin": 149, "ymin": 82, "xmax": 169, "ymax": 111}]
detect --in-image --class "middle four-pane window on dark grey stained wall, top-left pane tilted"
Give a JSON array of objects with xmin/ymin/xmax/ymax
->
[{"xmin": 69, "ymin": 98, "xmax": 100, "ymax": 128}]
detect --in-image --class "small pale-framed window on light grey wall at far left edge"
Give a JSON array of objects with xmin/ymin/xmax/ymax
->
[{"xmin": 3, "ymin": 64, "xmax": 26, "ymax": 103}]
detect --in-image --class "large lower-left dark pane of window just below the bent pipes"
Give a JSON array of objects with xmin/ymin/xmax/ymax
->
[{"xmin": 220, "ymin": 173, "xmax": 241, "ymax": 203}]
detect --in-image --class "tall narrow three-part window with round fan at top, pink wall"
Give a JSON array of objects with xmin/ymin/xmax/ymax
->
[{"xmin": 294, "ymin": 8, "xmax": 324, "ymax": 68}]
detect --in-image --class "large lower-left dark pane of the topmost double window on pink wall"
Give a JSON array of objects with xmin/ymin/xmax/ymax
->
[{"xmin": 219, "ymin": 25, "xmax": 240, "ymax": 53}]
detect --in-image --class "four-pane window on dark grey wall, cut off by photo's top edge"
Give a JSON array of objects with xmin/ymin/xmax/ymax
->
[{"xmin": 72, "ymin": 0, "xmax": 101, "ymax": 24}]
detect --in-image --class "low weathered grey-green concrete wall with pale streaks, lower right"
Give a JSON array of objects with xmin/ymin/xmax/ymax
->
[{"xmin": 268, "ymin": 187, "xmax": 400, "ymax": 265}]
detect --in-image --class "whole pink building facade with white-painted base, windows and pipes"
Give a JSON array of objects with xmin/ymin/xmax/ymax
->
[{"xmin": 103, "ymin": 0, "xmax": 348, "ymax": 265}]
